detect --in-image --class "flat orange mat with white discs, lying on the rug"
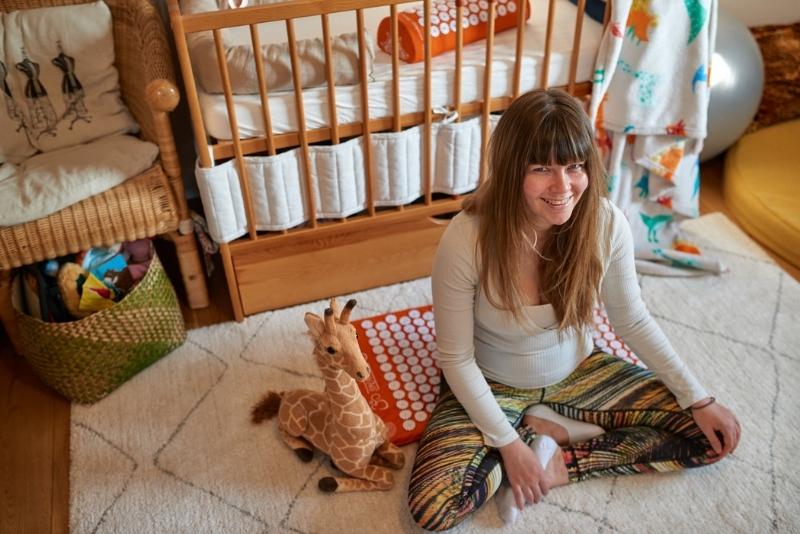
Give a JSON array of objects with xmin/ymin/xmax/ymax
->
[{"xmin": 352, "ymin": 306, "xmax": 643, "ymax": 445}]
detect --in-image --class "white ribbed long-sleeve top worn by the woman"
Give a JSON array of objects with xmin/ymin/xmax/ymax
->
[{"xmin": 432, "ymin": 199, "xmax": 708, "ymax": 447}]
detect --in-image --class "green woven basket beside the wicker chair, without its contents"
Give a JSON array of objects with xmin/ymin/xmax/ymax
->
[{"xmin": 17, "ymin": 253, "xmax": 186, "ymax": 404}]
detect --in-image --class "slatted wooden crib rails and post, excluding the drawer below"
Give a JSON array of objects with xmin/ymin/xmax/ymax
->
[{"xmin": 168, "ymin": 0, "xmax": 611, "ymax": 319}]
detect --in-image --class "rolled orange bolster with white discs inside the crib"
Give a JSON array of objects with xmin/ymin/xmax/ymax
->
[{"xmin": 378, "ymin": 0, "xmax": 531, "ymax": 63}]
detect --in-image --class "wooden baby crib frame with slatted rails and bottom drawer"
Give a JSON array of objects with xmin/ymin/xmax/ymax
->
[{"xmin": 169, "ymin": 0, "xmax": 610, "ymax": 320}]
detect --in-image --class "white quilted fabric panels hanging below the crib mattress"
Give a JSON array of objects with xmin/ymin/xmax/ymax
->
[{"xmin": 195, "ymin": 116, "xmax": 497, "ymax": 243}]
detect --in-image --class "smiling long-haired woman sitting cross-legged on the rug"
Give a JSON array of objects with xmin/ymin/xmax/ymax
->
[{"xmin": 408, "ymin": 90, "xmax": 740, "ymax": 530}]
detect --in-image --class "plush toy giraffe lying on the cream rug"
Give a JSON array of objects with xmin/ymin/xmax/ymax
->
[{"xmin": 252, "ymin": 299, "xmax": 405, "ymax": 492}]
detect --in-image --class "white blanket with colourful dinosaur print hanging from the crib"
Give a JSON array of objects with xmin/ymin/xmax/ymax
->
[{"xmin": 590, "ymin": 0, "xmax": 722, "ymax": 274}]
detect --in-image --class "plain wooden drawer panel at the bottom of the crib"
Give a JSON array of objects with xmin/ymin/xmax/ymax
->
[{"xmin": 232, "ymin": 219, "xmax": 446, "ymax": 316}]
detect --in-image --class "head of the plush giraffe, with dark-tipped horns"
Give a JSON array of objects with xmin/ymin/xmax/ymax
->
[{"xmin": 305, "ymin": 298, "xmax": 370, "ymax": 382}]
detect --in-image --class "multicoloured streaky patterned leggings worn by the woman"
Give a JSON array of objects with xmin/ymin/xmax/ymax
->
[{"xmin": 408, "ymin": 352, "xmax": 715, "ymax": 531}]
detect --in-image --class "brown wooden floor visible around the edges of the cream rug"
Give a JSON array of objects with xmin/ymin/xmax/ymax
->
[{"xmin": 0, "ymin": 154, "xmax": 800, "ymax": 533}]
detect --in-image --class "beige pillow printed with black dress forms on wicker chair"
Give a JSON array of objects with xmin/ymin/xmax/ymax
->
[{"xmin": 0, "ymin": 2, "xmax": 138, "ymax": 152}]
